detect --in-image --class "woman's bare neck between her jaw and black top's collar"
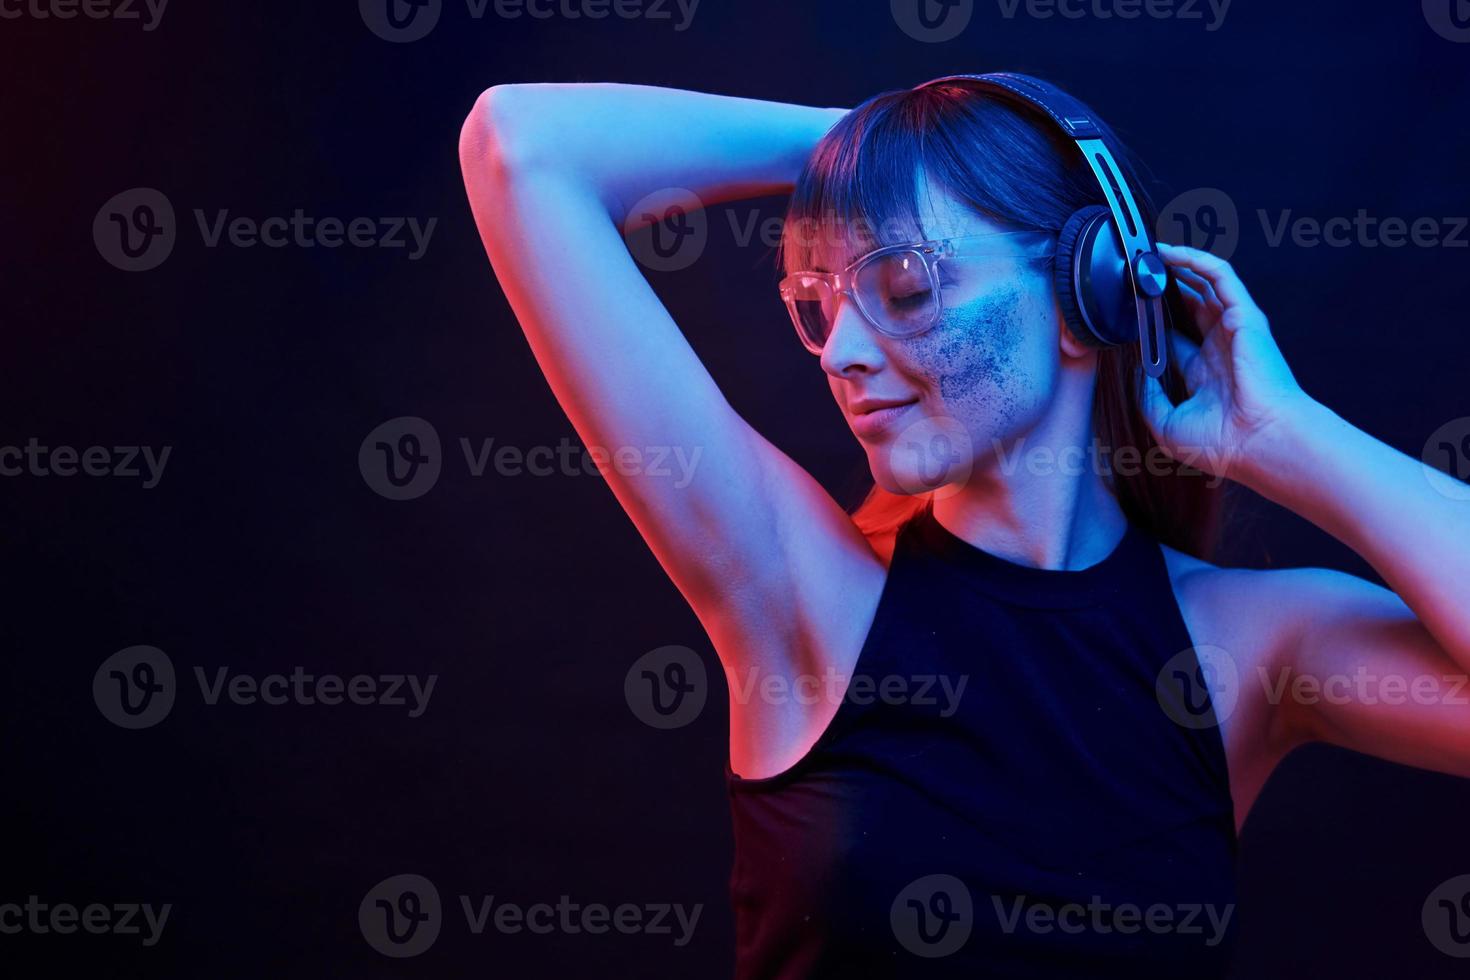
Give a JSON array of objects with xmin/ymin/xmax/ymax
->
[{"xmin": 933, "ymin": 372, "xmax": 1127, "ymax": 570}]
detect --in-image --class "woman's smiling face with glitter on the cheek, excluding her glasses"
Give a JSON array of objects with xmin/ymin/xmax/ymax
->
[{"xmin": 814, "ymin": 190, "xmax": 1061, "ymax": 495}]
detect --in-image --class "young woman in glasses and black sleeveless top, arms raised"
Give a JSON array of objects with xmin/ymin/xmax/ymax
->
[{"xmin": 460, "ymin": 72, "xmax": 1470, "ymax": 977}]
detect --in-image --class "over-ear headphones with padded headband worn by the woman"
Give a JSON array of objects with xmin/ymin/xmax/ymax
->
[{"xmin": 919, "ymin": 72, "xmax": 1169, "ymax": 378}]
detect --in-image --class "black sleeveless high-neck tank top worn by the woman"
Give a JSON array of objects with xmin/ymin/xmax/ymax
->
[{"xmin": 726, "ymin": 510, "xmax": 1236, "ymax": 980}]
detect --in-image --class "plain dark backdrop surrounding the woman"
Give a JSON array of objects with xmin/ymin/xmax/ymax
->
[{"xmin": 0, "ymin": 0, "xmax": 1470, "ymax": 977}]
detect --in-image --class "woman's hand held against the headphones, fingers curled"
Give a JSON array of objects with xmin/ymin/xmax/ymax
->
[{"xmin": 1142, "ymin": 242, "xmax": 1310, "ymax": 482}]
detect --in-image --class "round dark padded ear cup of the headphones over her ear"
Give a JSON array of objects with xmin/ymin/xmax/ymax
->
[{"xmin": 1053, "ymin": 204, "xmax": 1138, "ymax": 347}]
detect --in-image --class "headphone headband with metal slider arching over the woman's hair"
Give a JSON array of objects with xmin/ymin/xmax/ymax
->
[{"xmin": 916, "ymin": 72, "xmax": 1169, "ymax": 378}]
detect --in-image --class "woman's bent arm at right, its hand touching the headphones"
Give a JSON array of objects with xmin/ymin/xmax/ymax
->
[{"xmin": 1148, "ymin": 245, "xmax": 1470, "ymax": 776}]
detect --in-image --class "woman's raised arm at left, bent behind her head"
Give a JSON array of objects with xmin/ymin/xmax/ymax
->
[{"xmin": 460, "ymin": 84, "xmax": 882, "ymax": 765}]
